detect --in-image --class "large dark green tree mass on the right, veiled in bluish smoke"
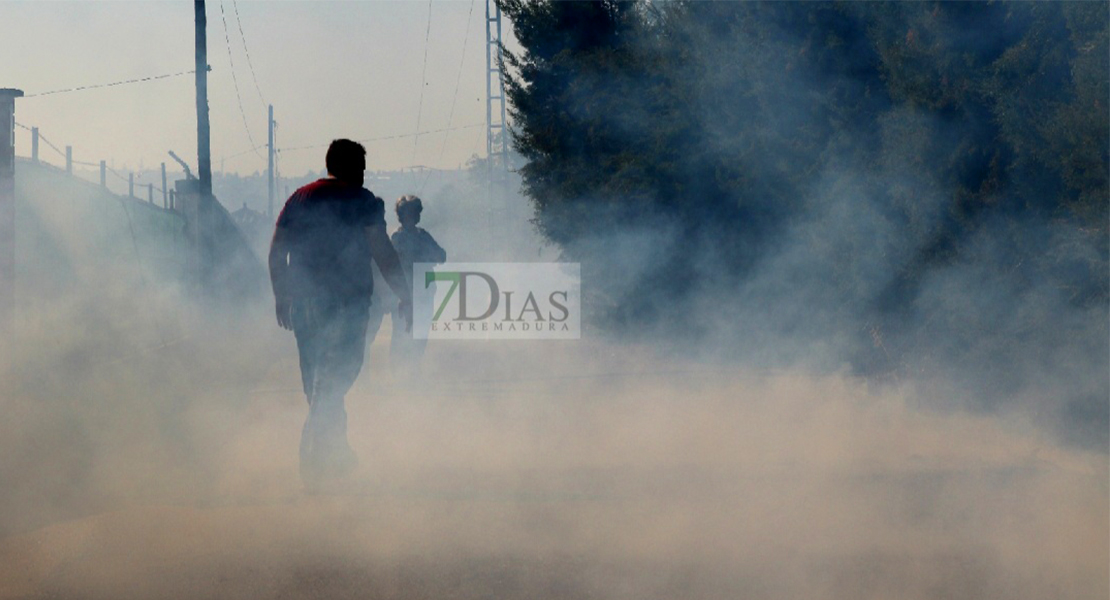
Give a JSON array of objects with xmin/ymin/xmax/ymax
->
[{"xmin": 503, "ymin": 0, "xmax": 1110, "ymax": 440}]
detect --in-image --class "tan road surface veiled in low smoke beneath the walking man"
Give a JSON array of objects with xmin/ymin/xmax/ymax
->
[{"xmin": 0, "ymin": 340, "xmax": 1110, "ymax": 600}]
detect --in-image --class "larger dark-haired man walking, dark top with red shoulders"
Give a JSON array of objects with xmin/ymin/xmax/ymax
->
[{"xmin": 270, "ymin": 140, "xmax": 412, "ymax": 488}]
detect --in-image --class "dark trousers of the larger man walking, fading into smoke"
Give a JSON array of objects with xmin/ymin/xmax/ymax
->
[{"xmin": 292, "ymin": 299, "xmax": 370, "ymax": 479}]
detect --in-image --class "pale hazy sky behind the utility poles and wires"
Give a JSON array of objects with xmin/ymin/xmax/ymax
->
[{"xmin": 0, "ymin": 0, "xmax": 511, "ymax": 175}]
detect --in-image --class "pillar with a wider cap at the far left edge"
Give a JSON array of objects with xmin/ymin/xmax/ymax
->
[{"xmin": 0, "ymin": 88, "xmax": 23, "ymax": 332}]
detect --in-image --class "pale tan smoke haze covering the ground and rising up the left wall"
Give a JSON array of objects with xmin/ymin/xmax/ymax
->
[{"xmin": 0, "ymin": 159, "xmax": 1110, "ymax": 600}]
